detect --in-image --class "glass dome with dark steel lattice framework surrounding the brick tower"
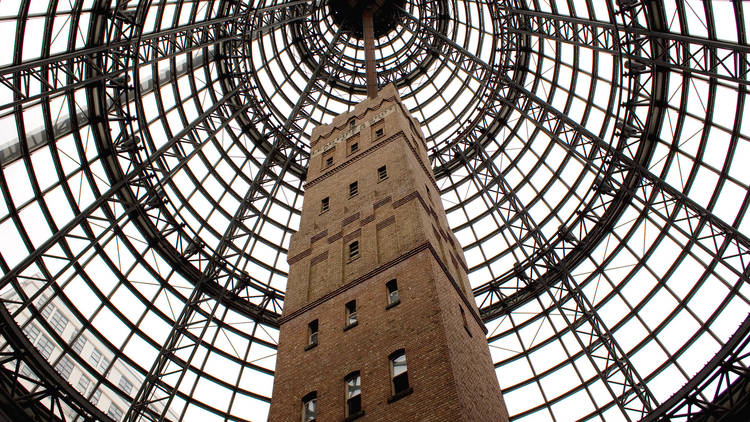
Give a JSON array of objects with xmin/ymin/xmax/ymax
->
[{"xmin": 0, "ymin": 0, "xmax": 750, "ymax": 421}]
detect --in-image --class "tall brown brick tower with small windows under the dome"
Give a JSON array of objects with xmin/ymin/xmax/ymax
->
[{"xmin": 269, "ymin": 85, "xmax": 508, "ymax": 422}]
